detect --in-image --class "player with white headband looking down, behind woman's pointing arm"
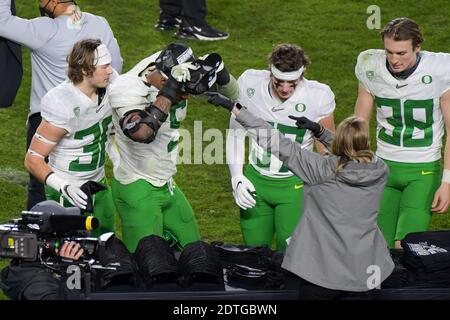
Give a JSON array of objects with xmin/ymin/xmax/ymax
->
[{"xmin": 226, "ymin": 44, "xmax": 335, "ymax": 250}]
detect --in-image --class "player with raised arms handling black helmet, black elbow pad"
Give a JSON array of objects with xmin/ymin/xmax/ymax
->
[{"xmin": 111, "ymin": 43, "xmax": 237, "ymax": 252}]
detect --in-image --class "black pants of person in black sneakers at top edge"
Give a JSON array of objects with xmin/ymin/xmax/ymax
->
[{"xmin": 159, "ymin": 0, "xmax": 207, "ymax": 27}]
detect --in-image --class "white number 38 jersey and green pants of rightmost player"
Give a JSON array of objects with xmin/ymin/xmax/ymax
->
[{"xmin": 355, "ymin": 50, "xmax": 450, "ymax": 247}]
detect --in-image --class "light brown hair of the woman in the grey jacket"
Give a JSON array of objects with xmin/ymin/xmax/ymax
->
[{"xmin": 331, "ymin": 116, "xmax": 374, "ymax": 173}]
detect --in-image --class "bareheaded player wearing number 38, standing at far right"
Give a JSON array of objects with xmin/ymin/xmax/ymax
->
[{"xmin": 355, "ymin": 18, "xmax": 450, "ymax": 247}]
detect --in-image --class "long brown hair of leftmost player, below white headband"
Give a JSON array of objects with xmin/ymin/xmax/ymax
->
[{"xmin": 67, "ymin": 39, "xmax": 101, "ymax": 84}]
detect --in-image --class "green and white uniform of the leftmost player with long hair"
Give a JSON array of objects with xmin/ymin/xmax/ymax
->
[{"xmin": 41, "ymin": 78, "xmax": 117, "ymax": 235}]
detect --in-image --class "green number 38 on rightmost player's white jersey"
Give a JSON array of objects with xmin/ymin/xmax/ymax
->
[{"xmin": 375, "ymin": 97, "xmax": 434, "ymax": 148}]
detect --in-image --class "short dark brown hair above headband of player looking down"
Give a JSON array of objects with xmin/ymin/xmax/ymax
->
[{"xmin": 269, "ymin": 44, "xmax": 310, "ymax": 72}]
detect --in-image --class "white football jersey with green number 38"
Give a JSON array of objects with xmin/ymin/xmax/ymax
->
[{"xmin": 355, "ymin": 49, "xmax": 450, "ymax": 163}]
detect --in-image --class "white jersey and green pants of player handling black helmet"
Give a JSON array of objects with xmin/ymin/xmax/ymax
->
[{"xmin": 111, "ymin": 52, "xmax": 200, "ymax": 252}]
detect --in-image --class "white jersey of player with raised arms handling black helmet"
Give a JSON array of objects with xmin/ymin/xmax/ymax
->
[{"xmin": 111, "ymin": 52, "xmax": 187, "ymax": 187}]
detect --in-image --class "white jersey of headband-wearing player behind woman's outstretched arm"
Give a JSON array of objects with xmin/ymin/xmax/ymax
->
[{"xmin": 238, "ymin": 70, "xmax": 336, "ymax": 178}]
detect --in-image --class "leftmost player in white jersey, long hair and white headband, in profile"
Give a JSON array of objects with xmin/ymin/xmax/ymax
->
[{"xmin": 25, "ymin": 39, "xmax": 117, "ymax": 235}]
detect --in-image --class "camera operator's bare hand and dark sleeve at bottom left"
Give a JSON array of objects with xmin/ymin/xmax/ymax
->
[{"xmin": 0, "ymin": 241, "xmax": 84, "ymax": 300}]
